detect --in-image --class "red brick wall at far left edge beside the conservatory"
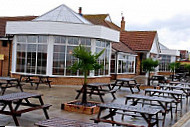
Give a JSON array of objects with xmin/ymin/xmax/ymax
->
[{"xmin": 0, "ymin": 41, "xmax": 12, "ymax": 76}]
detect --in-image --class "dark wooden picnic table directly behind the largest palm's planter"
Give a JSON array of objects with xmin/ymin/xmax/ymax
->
[{"xmin": 75, "ymin": 83, "xmax": 117, "ymax": 102}]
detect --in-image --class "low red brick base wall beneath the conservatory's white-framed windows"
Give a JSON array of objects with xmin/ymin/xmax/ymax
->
[{"xmin": 12, "ymin": 74, "xmax": 111, "ymax": 85}]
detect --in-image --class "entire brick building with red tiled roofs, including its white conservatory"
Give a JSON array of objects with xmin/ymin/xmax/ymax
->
[{"xmin": 0, "ymin": 5, "xmax": 183, "ymax": 85}]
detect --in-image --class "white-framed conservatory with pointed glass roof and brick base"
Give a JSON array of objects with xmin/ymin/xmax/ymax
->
[{"xmin": 6, "ymin": 5, "xmax": 119, "ymax": 84}]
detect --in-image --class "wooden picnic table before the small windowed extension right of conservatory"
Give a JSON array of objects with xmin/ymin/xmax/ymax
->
[{"xmin": 112, "ymin": 78, "xmax": 140, "ymax": 94}]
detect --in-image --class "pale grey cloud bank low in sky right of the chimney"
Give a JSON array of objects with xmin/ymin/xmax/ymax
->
[{"xmin": 117, "ymin": 14, "xmax": 190, "ymax": 49}]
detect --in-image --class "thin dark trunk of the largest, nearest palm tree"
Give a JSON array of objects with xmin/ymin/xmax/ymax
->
[{"xmin": 82, "ymin": 71, "xmax": 87, "ymax": 104}]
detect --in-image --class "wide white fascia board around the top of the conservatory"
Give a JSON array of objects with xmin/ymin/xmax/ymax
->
[{"xmin": 6, "ymin": 21, "xmax": 120, "ymax": 42}]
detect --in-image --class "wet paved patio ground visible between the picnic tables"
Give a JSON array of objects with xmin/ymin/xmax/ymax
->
[{"xmin": 0, "ymin": 84, "xmax": 189, "ymax": 127}]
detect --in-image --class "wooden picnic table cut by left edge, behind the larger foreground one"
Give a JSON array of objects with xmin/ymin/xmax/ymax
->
[{"xmin": 0, "ymin": 77, "xmax": 23, "ymax": 95}]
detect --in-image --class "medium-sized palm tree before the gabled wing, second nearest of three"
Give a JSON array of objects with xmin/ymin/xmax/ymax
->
[{"xmin": 142, "ymin": 58, "xmax": 158, "ymax": 86}]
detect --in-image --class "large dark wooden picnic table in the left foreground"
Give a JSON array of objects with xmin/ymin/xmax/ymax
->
[{"xmin": 0, "ymin": 92, "xmax": 51, "ymax": 126}]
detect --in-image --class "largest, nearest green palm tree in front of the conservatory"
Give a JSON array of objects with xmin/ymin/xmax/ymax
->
[{"xmin": 70, "ymin": 45, "xmax": 105, "ymax": 104}]
